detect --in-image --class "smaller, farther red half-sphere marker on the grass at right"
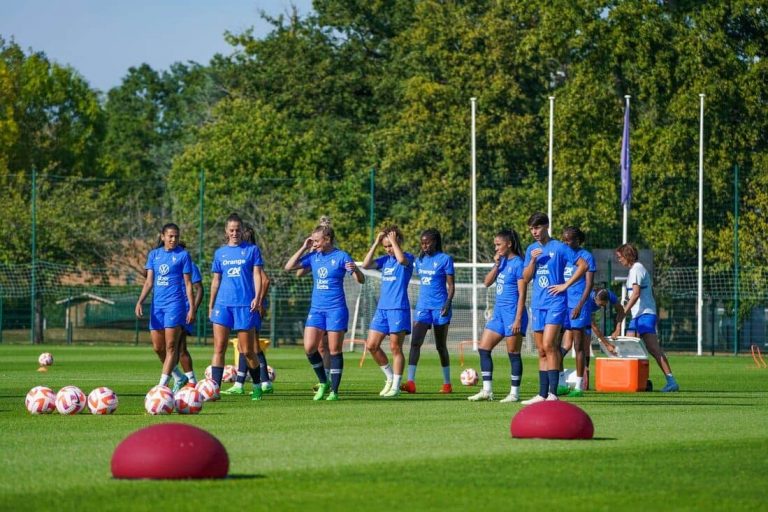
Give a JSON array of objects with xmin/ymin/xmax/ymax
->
[{"xmin": 509, "ymin": 400, "xmax": 595, "ymax": 439}]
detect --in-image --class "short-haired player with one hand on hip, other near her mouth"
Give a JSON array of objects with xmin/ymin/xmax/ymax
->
[{"xmin": 522, "ymin": 212, "xmax": 587, "ymax": 405}]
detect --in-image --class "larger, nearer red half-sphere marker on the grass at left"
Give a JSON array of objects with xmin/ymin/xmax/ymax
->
[{"xmin": 112, "ymin": 423, "xmax": 229, "ymax": 479}]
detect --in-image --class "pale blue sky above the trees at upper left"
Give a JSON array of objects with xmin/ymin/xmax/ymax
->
[{"xmin": 0, "ymin": 0, "xmax": 312, "ymax": 92}]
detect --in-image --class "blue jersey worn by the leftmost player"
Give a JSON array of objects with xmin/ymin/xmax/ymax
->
[{"xmin": 144, "ymin": 247, "xmax": 192, "ymax": 307}]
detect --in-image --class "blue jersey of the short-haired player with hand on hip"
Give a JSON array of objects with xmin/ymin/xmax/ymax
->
[{"xmin": 524, "ymin": 239, "xmax": 574, "ymax": 310}]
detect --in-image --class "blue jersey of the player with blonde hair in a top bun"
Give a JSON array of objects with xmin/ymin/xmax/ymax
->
[{"xmin": 300, "ymin": 247, "xmax": 353, "ymax": 309}]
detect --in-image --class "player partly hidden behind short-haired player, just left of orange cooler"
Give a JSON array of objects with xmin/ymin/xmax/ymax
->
[{"xmin": 560, "ymin": 226, "xmax": 597, "ymax": 397}]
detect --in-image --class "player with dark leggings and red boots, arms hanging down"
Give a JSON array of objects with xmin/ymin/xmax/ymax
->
[{"xmin": 400, "ymin": 228, "xmax": 456, "ymax": 393}]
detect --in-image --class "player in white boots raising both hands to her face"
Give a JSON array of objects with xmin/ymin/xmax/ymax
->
[{"xmin": 363, "ymin": 226, "xmax": 415, "ymax": 398}]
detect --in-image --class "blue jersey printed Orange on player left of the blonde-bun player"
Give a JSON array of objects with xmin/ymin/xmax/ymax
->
[{"xmin": 211, "ymin": 242, "xmax": 264, "ymax": 306}]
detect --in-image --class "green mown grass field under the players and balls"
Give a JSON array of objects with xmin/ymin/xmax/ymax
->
[{"xmin": 0, "ymin": 345, "xmax": 768, "ymax": 512}]
